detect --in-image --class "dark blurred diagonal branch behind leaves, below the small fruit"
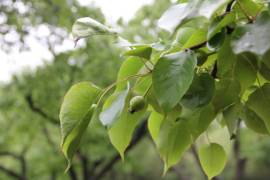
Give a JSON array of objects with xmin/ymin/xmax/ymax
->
[{"xmin": 93, "ymin": 120, "xmax": 147, "ymax": 180}]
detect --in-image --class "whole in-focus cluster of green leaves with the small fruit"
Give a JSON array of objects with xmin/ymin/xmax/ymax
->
[{"xmin": 60, "ymin": 0, "xmax": 270, "ymax": 179}]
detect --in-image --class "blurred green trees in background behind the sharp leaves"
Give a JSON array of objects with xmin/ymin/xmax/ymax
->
[{"xmin": 0, "ymin": 0, "xmax": 270, "ymax": 180}]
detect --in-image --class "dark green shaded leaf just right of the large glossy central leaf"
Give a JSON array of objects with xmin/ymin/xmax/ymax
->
[{"xmin": 181, "ymin": 73, "xmax": 215, "ymax": 109}]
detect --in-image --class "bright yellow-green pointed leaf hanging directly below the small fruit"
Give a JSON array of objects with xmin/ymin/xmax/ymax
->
[{"xmin": 108, "ymin": 107, "xmax": 146, "ymax": 159}]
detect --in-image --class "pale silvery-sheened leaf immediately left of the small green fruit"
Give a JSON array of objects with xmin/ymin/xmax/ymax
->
[{"xmin": 99, "ymin": 85, "xmax": 129, "ymax": 126}]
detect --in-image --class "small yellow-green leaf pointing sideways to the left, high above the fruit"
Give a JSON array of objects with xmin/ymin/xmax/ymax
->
[{"xmin": 123, "ymin": 46, "xmax": 152, "ymax": 60}]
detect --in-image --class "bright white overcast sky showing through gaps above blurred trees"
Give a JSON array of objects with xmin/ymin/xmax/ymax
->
[{"xmin": 0, "ymin": 0, "xmax": 153, "ymax": 82}]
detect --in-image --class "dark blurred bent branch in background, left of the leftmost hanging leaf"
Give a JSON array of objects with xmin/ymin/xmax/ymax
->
[{"xmin": 25, "ymin": 94, "xmax": 59, "ymax": 125}]
